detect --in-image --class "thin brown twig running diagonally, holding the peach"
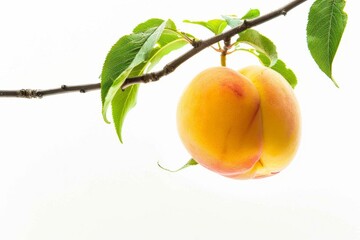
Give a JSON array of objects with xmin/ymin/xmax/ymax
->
[{"xmin": 0, "ymin": 0, "xmax": 307, "ymax": 98}]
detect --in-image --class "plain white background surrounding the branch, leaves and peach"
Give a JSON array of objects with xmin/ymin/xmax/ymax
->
[{"xmin": 0, "ymin": 0, "xmax": 360, "ymax": 240}]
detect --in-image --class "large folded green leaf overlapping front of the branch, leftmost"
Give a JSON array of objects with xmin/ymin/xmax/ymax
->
[{"xmin": 101, "ymin": 19, "xmax": 166, "ymax": 122}]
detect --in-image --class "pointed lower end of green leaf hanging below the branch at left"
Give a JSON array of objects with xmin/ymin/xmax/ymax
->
[{"xmin": 111, "ymin": 84, "xmax": 139, "ymax": 143}]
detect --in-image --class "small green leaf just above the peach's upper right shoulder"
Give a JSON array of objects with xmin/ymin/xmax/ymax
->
[{"xmin": 257, "ymin": 53, "xmax": 297, "ymax": 88}]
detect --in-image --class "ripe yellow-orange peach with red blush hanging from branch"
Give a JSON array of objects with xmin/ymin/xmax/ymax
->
[{"xmin": 177, "ymin": 66, "xmax": 301, "ymax": 179}]
